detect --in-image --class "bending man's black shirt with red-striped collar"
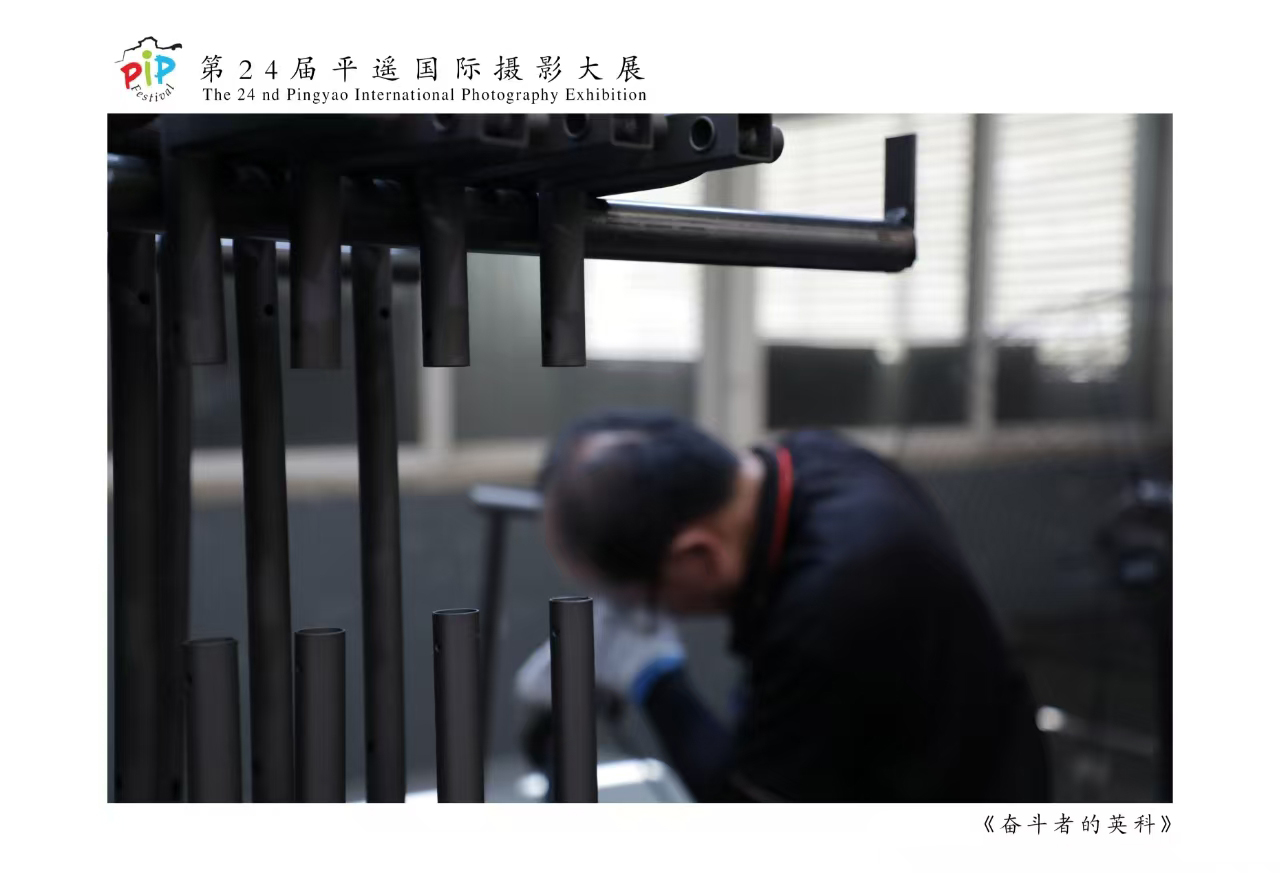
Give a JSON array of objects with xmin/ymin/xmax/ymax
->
[{"xmin": 645, "ymin": 431, "xmax": 1048, "ymax": 803}]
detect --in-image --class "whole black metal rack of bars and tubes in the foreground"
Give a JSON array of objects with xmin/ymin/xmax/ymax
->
[{"xmin": 108, "ymin": 114, "xmax": 915, "ymax": 801}]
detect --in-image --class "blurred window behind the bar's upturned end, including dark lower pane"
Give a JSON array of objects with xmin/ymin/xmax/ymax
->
[{"xmin": 758, "ymin": 115, "xmax": 973, "ymax": 428}]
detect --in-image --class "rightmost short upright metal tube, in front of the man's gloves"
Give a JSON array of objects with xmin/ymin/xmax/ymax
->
[{"xmin": 550, "ymin": 597, "xmax": 599, "ymax": 804}]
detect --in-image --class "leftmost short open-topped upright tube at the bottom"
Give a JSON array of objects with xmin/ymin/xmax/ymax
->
[{"xmin": 184, "ymin": 637, "xmax": 244, "ymax": 804}]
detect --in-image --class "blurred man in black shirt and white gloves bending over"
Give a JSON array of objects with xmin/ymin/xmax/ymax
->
[{"xmin": 517, "ymin": 411, "xmax": 1048, "ymax": 803}]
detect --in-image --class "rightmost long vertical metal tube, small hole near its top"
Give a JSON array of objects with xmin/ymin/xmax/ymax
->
[{"xmin": 351, "ymin": 246, "xmax": 404, "ymax": 803}]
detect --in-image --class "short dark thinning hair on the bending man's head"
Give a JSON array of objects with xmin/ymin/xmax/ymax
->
[{"xmin": 538, "ymin": 410, "xmax": 739, "ymax": 582}]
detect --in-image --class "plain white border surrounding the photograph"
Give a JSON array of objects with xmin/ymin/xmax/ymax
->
[{"xmin": 0, "ymin": 0, "xmax": 1280, "ymax": 873}]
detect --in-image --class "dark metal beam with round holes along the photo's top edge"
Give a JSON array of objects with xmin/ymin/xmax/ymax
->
[{"xmin": 129, "ymin": 114, "xmax": 783, "ymax": 197}]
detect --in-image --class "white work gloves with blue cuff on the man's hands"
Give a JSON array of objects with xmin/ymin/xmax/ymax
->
[{"xmin": 516, "ymin": 597, "xmax": 685, "ymax": 707}]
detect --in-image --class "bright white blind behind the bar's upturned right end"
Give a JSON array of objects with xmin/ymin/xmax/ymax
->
[{"xmin": 758, "ymin": 115, "xmax": 973, "ymax": 356}]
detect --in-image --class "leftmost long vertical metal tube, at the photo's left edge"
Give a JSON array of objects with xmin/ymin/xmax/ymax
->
[{"xmin": 108, "ymin": 233, "xmax": 161, "ymax": 803}]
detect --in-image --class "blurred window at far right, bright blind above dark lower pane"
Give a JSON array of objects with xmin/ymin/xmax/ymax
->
[{"xmin": 988, "ymin": 115, "xmax": 1137, "ymax": 421}]
